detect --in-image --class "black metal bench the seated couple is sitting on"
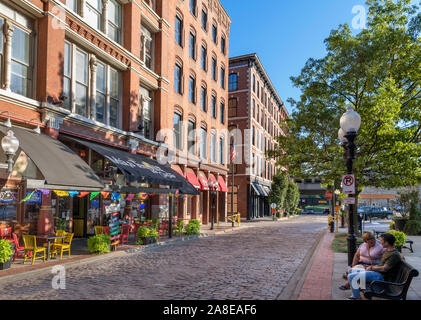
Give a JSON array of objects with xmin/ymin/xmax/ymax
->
[{"xmin": 361, "ymin": 261, "xmax": 419, "ymax": 300}]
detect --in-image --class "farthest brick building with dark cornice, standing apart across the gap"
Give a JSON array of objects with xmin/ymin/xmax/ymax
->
[{"xmin": 228, "ymin": 54, "xmax": 288, "ymax": 219}]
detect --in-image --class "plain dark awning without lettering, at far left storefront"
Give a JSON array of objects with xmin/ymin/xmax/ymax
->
[{"xmin": 0, "ymin": 127, "xmax": 104, "ymax": 191}]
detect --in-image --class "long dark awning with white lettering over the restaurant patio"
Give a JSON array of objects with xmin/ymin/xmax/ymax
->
[{"xmin": 70, "ymin": 138, "xmax": 198, "ymax": 194}]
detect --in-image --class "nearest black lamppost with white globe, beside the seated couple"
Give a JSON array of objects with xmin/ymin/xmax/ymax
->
[{"xmin": 338, "ymin": 105, "xmax": 361, "ymax": 266}]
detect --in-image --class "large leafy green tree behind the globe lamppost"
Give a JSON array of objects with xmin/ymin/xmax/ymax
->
[{"xmin": 269, "ymin": 0, "xmax": 421, "ymax": 195}]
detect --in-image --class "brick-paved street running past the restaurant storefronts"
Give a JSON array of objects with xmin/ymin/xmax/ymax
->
[{"xmin": 0, "ymin": 216, "xmax": 327, "ymax": 300}]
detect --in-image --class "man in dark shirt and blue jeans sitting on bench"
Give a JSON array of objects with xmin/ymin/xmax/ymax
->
[{"xmin": 348, "ymin": 233, "xmax": 402, "ymax": 300}]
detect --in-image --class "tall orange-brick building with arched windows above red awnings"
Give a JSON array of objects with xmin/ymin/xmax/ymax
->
[{"xmin": 166, "ymin": 0, "xmax": 231, "ymax": 224}]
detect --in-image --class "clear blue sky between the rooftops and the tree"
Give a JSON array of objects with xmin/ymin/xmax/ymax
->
[{"xmin": 220, "ymin": 0, "xmax": 365, "ymax": 112}]
